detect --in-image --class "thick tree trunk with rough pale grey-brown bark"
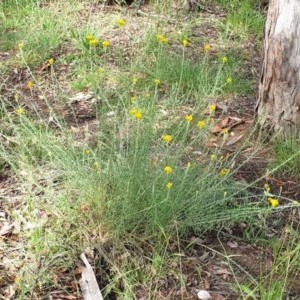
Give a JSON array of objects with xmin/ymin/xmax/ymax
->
[{"xmin": 256, "ymin": 0, "xmax": 300, "ymax": 132}]
